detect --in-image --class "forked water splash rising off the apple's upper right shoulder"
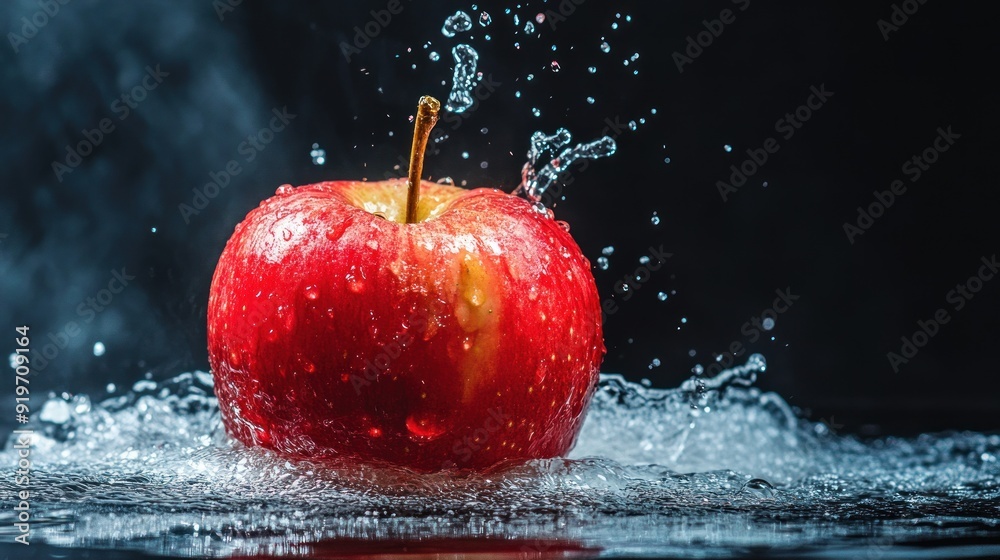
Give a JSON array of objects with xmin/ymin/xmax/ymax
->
[{"xmin": 514, "ymin": 128, "xmax": 618, "ymax": 210}]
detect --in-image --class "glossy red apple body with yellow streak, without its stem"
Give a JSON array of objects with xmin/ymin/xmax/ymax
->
[{"xmin": 208, "ymin": 181, "xmax": 605, "ymax": 472}]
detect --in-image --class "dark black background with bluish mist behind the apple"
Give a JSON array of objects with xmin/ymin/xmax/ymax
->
[{"xmin": 0, "ymin": 0, "xmax": 1000, "ymax": 434}]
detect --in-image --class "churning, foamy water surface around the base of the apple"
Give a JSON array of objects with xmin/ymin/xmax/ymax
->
[{"xmin": 0, "ymin": 355, "xmax": 1000, "ymax": 558}]
